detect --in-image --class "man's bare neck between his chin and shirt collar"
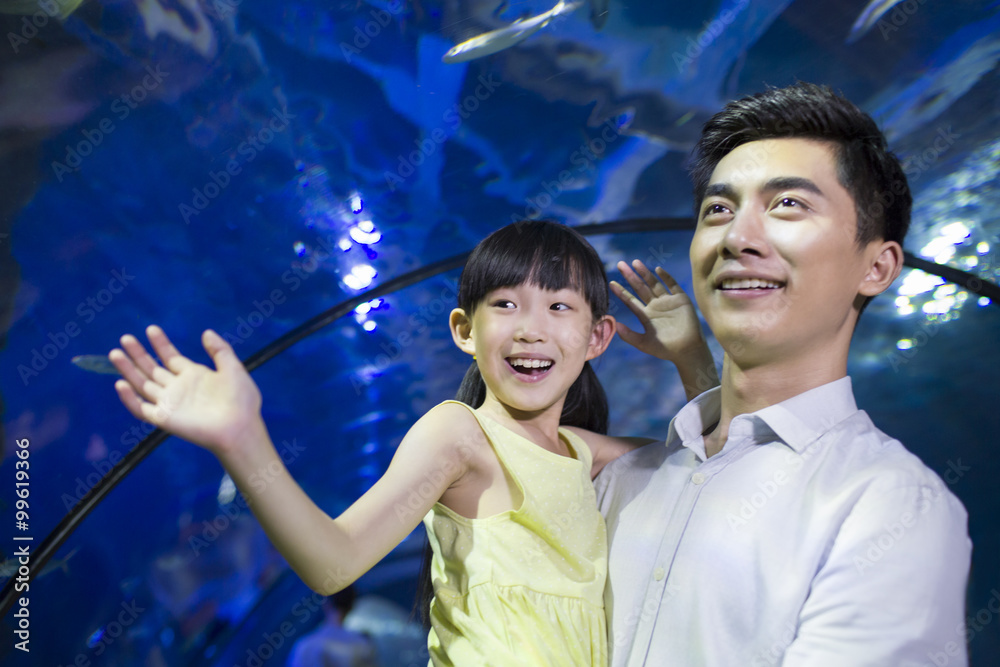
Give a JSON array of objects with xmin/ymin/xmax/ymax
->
[{"xmin": 705, "ymin": 351, "xmax": 847, "ymax": 457}]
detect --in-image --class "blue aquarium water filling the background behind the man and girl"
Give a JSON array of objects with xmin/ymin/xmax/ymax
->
[{"xmin": 0, "ymin": 0, "xmax": 1000, "ymax": 667}]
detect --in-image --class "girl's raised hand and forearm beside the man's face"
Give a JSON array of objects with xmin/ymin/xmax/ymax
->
[{"xmin": 611, "ymin": 259, "xmax": 719, "ymax": 400}]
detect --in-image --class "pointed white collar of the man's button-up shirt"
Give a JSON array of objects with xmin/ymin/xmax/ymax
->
[{"xmin": 667, "ymin": 376, "xmax": 858, "ymax": 452}]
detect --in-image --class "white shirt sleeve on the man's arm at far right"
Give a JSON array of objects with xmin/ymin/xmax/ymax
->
[{"xmin": 782, "ymin": 479, "xmax": 971, "ymax": 667}]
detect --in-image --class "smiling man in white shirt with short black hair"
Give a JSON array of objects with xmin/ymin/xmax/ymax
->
[{"xmin": 596, "ymin": 84, "xmax": 971, "ymax": 667}]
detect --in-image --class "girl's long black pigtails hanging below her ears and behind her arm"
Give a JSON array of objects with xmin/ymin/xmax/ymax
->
[{"xmin": 417, "ymin": 361, "xmax": 608, "ymax": 629}]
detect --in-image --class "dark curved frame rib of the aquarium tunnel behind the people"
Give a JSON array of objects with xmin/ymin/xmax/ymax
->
[{"xmin": 0, "ymin": 218, "xmax": 1000, "ymax": 615}]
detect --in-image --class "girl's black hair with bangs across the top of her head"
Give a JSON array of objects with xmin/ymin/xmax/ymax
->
[{"xmin": 458, "ymin": 221, "xmax": 608, "ymax": 318}]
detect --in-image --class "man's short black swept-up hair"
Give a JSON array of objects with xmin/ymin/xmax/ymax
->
[{"xmin": 690, "ymin": 83, "xmax": 913, "ymax": 246}]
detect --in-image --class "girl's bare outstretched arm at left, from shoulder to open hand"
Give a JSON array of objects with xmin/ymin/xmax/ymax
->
[{"xmin": 109, "ymin": 327, "xmax": 481, "ymax": 594}]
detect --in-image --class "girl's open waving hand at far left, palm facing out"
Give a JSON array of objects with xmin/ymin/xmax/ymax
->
[{"xmin": 108, "ymin": 325, "xmax": 261, "ymax": 454}]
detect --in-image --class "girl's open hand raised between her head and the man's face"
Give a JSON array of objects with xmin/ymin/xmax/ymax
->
[{"xmin": 611, "ymin": 259, "xmax": 705, "ymax": 365}]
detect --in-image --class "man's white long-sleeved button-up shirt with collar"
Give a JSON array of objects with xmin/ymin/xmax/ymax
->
[{"xmin": 595, "ymin": 377, "xmax": 971, "ymax": 667}]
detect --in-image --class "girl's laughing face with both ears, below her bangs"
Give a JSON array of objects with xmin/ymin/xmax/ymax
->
[{"xmin": 451, "ymin": 284, "xmax": 614, "ymax": 417}]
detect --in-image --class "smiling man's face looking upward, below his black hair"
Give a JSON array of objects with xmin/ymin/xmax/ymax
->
[{"xmin": 691, "ymin": 139, "xmax": 871, "ymax": 365}]
